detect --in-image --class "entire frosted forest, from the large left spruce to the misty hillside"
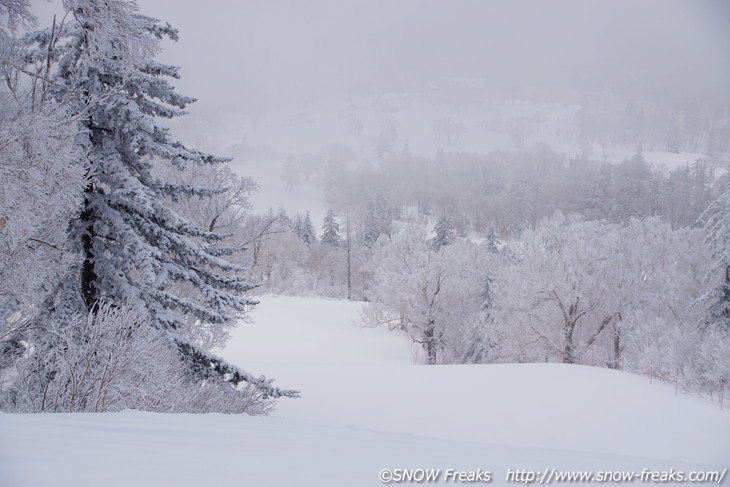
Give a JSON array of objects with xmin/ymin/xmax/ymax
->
[{"xmin": 0, "ymin": 0, "xmax": 730, "ymax": 415}]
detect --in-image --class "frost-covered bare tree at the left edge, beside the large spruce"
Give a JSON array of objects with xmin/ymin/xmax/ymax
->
[{"xmin": 0, "ymin": 0, "xmax": 85, "ymax": 358}]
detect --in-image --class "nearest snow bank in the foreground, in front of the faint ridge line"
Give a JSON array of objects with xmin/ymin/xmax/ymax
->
[{"xmin": 0, "ymin": 411, "xmax": 714, "ymax": 487}]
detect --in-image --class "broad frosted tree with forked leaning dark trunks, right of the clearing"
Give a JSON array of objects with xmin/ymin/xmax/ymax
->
[{"xmin": 496, "ymin": 215, "xmax": 618, "ymax": 363}]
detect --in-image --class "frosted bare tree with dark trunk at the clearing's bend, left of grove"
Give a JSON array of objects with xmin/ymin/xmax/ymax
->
[{"xmin": 364, "ymin": 226, "xmax": 484, "ymax": 364}]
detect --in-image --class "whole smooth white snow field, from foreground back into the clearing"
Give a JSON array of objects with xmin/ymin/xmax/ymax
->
[{"xmin": 0, "ymin": 296, "xmax": 730, "ymax": 487}]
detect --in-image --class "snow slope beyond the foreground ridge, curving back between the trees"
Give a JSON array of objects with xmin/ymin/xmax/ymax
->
[{"xmin": 221, "ymin": 297, "xmax": 730, "ymax": 465}]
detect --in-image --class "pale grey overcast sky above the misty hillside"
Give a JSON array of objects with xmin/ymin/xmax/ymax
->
[{"xmin": 35, "ymin": 0, "xmax": 730, "ymax": 110}]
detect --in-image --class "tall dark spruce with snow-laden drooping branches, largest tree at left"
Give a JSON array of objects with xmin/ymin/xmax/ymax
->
[{"xmin": 33, "ymin": 0, "xmax": 297, "ymax": 408}]
